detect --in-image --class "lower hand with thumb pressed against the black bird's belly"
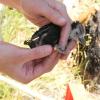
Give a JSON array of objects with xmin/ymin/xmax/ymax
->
[{"xmin": 0, "ymin": 42, "xmax": 60, "ymax": 83}]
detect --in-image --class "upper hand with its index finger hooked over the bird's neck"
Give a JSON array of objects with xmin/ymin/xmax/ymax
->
[{"xmin": 20, "ymin": 0, "xmax": 75, "ymax": 59}]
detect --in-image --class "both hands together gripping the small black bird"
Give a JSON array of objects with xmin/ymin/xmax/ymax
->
[{"xmin": 0, "ymin": 0, "xmax": 75, "ymax": 83}]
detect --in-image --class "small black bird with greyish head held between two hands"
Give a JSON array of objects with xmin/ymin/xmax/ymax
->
[{"xmin": 24, "ymin": 21, "xmax": 85, "ymax": 53}]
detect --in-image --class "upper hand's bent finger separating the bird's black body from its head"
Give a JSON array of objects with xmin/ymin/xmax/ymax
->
[{"xmin": 44, "ymin": 0, "xmax": 71, "ymax": 48}]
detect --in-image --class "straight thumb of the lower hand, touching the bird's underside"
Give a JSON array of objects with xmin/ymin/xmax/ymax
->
[{"xmin": 22, "ymin": 45, "xmax": 52, "ymax": 62}]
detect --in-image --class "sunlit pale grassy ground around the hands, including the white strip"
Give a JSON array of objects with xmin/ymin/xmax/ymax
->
[{"xmin": 0, "ymin": 0, "xmax": 100, "ymax": 100}]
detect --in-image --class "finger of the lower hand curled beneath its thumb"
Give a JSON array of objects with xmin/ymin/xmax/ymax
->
[{"xmin": 33, "ymin": 52, "xmax": 60, "ymax": 79}]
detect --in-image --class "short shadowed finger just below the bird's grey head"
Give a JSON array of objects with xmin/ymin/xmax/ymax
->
[{"xmin": 61, "ymin": 40, "xmax": 77, "ymax": 60}]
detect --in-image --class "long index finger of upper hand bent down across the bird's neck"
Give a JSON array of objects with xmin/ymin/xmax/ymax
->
[{"xmin": 55, "ymin": 2, "xmax": 71, "ymax": 48}]
